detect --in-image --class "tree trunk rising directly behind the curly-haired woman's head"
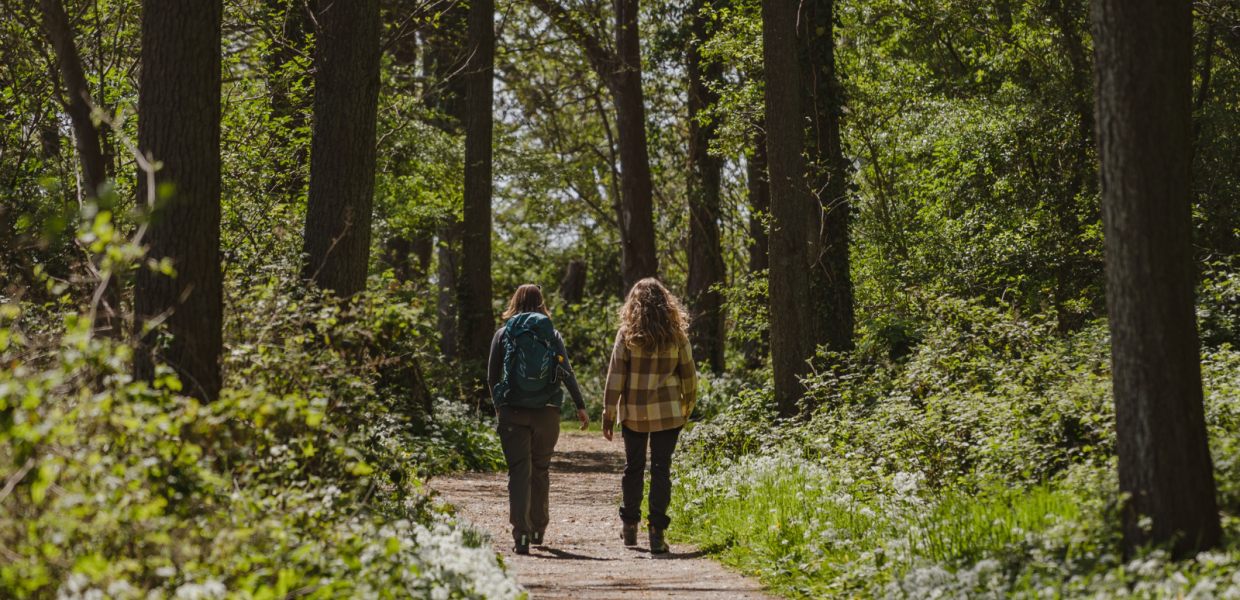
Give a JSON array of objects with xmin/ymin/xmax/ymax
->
[{"xmin": 608, "ymin": 0, "xmax": 658, "ymax": 291}]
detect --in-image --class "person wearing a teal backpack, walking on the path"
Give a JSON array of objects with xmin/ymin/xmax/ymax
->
[{"xmin": 486, "ymin": 284, "xmax": 590, "ymax": 554}]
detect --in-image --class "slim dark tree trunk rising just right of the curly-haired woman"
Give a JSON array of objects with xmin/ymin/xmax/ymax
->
[{"xmin": 684, "ymin": 0, "xmax": 725, "ymax": 373}]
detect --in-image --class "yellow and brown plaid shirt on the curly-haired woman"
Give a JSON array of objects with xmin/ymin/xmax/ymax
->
[{"xmin": 603, "ymin": 333, "xmax": 697, "ymax": 431}]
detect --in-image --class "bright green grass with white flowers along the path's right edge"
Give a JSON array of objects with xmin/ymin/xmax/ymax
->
[{"xmin": 670, "ymin": 462, "xmax": 1080, "ymax": 598}]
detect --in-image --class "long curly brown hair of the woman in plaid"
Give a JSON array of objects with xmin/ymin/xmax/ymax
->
[{"xmin": 620, "ymin": 278, "xmax": 689, "ymax": 352}]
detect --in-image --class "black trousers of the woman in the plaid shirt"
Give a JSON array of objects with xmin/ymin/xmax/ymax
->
[{"xmin": 620, "ymin": 426, "xmax": 681, "ymax": 529}]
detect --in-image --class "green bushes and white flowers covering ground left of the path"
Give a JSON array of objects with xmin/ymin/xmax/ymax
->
[{"xmin": 0, "ymin": 220, "xmax": 513, "ymax": 600}]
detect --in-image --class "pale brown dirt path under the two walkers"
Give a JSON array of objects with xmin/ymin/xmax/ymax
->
[{"xmin": 430, "ymin": 431, "xmax": 771, "ymax": 600}]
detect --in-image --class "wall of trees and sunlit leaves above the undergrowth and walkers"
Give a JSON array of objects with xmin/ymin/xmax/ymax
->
[{"xmin": 0, "ymin": 0, "xmax": 1240, "ymax": 557}]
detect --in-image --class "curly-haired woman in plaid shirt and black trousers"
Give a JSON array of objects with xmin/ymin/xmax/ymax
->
[{"xmin": 603, "ymin": 278, "xmax": 697, "ymax": 554}]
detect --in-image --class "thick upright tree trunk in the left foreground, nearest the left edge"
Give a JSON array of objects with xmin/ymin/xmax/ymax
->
[{"xmin": 134, "ymin": 0, "xmax": 223, "ymax": 402}]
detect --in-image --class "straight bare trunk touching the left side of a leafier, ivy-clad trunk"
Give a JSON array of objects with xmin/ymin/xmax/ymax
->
[{"xmin": 761, "ymin": 0, "xmax": 821, "ymax": 417}]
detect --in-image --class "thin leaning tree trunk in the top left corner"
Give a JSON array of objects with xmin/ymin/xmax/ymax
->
[{"xmin": 38, "ymin": 0, "xmax": 108, "ymax": 198}]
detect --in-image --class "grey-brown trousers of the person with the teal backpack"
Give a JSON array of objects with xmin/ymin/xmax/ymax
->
[{"xmin": 498, "ymin": 407, "xmax": 559, "ymax": 540}]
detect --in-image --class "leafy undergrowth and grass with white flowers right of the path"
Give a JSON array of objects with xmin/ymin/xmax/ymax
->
[{"xmin": 671, "ymin": 292, "xmax": 1240, "ymax": 599}]
